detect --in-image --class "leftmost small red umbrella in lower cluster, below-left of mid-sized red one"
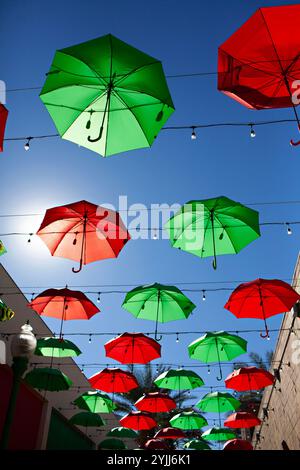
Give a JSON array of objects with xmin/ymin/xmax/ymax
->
[{"xmin": 89, "ymin": 367, "xmax": 139, "ymax": 393}]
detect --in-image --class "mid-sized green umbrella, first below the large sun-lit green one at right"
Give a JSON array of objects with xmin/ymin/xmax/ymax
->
[{"xmin": 188, "ymin": 331, "xmax": 247, "ymax": 380}]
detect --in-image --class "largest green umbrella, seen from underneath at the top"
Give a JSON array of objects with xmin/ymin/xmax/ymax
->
[{"xmin": 40, "ymin": 34, "xmax": 174, "ymax": 156}]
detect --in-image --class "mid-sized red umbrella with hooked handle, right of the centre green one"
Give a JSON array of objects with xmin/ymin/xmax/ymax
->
[{"xmin": 224, "ymin": 279, "xmax": 300, "ymax": 338}]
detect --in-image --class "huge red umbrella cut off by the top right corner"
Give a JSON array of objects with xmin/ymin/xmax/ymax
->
[{"xmin": 218, "ymin": 5, "xmax": 300, "ymax": 145}]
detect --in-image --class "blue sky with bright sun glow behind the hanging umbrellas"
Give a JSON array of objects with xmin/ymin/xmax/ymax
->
[{"xmin": 0, "ymin": 0, "xmax": 300, "ymax": 434}]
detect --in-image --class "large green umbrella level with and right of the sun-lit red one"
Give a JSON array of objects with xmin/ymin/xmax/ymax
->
[{"xmin": 165, "ymin": 196, "xmax": 260, "ymax": 269}]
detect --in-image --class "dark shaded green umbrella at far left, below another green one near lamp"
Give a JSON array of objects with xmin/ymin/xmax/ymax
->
[{"xmin": 25, "ymin": 367, "xmax": 73, "ymax": 392}]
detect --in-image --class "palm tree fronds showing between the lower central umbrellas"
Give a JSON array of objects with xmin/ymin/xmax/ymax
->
[{"xmin": 114, "ymin": 364, "xmax": 199, "ymax": 448}]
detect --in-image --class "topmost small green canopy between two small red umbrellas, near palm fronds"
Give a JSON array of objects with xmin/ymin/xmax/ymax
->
[{"xmin": 154, "ymin": 369, "xmax": 204, "ymax": 390}]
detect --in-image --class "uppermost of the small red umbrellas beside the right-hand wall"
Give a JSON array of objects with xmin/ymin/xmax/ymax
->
[{"xmin": 225, "ymin": 367, "xmax": 275, "ymax": 392}]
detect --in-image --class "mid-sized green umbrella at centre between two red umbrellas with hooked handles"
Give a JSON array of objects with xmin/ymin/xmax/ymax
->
[{"xmin": 122, "ymin": 283, "xmax": 196, "ymax": 340}]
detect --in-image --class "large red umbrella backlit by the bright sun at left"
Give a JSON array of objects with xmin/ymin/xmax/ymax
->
[{"xmin": 37, "ymin": 201, "xmax": 130, "ymax": 273}]
